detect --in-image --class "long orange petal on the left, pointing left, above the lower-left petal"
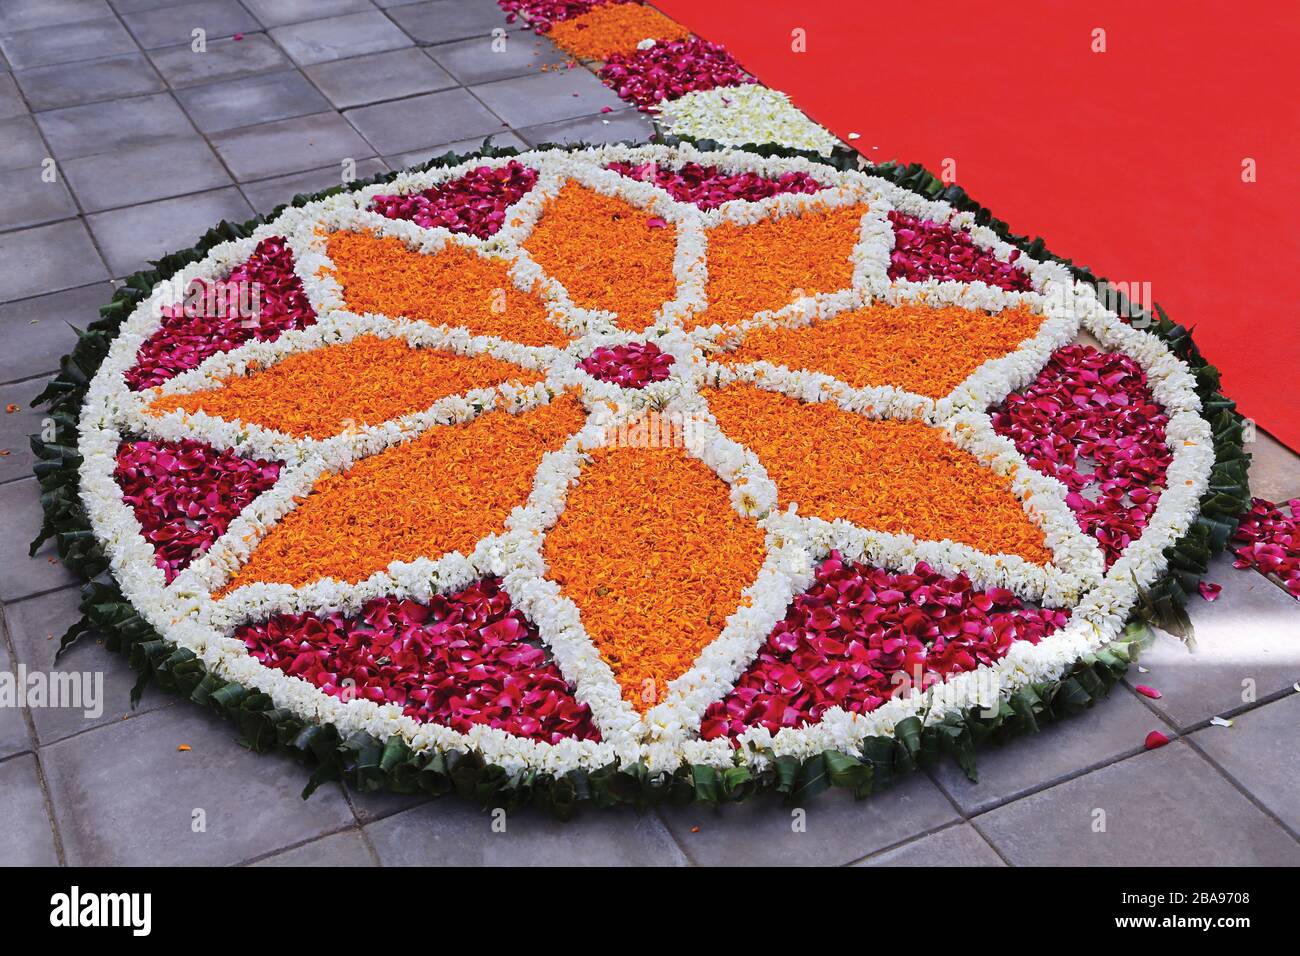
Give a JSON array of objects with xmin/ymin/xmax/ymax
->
[{"xmin": 150, "ymin": 336, "xmax": 542, "ymax": 438}]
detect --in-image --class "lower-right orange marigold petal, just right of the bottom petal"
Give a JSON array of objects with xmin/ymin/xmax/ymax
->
[{"xmin": 705, "ymin": 385, "xmax": 1052, "ymax": 564}]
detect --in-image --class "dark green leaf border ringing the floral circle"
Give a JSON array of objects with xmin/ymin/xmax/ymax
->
[{"xmin": 31, "ymin": 137, "xmax": 1249, "ymax": 818}]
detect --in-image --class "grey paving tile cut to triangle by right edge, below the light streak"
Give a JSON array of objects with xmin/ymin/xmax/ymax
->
[{"xmin": 1191, "ymin": 693, "xmax": 1300, "ymax": 834}]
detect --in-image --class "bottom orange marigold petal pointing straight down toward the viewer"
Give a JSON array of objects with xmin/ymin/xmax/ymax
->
[{"xmin": 543, "ymin": 447, "xmax": 763, "ymax": 710}]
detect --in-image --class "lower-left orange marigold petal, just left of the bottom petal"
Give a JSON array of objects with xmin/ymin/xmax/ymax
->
[{"xmin": 222, "ymin": 395, "xmax": 585, "ymax": 593}]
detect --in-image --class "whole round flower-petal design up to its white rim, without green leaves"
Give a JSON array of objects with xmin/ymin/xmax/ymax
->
[{"xmin": 78, "ymin": 146, "xmax": 1214, "ymax": 796}]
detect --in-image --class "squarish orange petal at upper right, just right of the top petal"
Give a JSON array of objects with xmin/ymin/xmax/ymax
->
[{"xmin": 686, "ymin": 200, "xmax": 867, "ymax": 329}]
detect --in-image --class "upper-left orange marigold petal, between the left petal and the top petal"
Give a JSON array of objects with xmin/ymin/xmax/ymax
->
[{"xmin": 328, "ymin": 232, "xmax": 568, "ymax": 346}]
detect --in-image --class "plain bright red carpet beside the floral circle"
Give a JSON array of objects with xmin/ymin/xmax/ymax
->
[{"xmin": 655, "ymin": 0, "xmax": 1300, "ymax": 450}]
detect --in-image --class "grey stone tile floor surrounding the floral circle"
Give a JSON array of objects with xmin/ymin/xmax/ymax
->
[{"xmin": 0, "ymin": 0, "xmax": 1300, "ymax": 866}]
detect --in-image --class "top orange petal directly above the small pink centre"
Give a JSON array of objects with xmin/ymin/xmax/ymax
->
[{"xmin": 524, "ymin": 182, "xmax": 677, "ymax": 332}]
